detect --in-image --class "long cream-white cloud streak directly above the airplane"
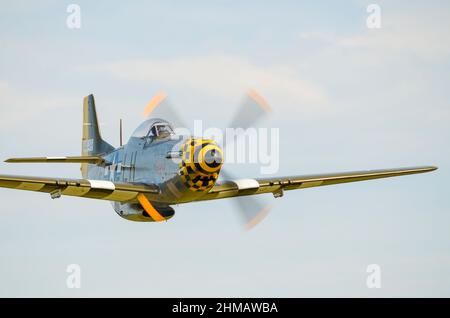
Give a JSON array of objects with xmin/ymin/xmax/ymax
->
[{"xmin": 97, "ymin": 55, "xmax": 327, "ymax": 105}]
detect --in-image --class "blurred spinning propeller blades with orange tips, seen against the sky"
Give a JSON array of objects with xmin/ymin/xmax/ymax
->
[{"xmin": 143, "ymin": 89, "xmax": 272, "ymax": 230}]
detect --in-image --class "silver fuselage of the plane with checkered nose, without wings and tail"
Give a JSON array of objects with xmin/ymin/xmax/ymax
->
[{"xmin": 83, "ymin": 119, "xmax": 223, "ymax": 221}]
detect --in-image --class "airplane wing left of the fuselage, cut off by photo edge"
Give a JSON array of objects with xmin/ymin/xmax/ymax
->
[{"xmin": 0, "ymin": 175, "xmax": 160, "ymax": 202}]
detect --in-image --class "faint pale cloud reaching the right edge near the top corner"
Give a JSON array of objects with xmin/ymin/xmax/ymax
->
[{"xmin": 299, "ymin": 7, "xmax": 450, "ymax": 63}]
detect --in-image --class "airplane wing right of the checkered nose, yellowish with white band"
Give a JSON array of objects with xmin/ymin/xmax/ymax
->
[{"xmin": 200, "ymin": 167, "xmax": 437, "ymax": 201}]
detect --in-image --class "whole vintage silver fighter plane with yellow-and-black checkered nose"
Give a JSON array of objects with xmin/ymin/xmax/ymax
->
[{"xmin": 0, "ymin": 95, "xmax": 437, "ymax": 227}]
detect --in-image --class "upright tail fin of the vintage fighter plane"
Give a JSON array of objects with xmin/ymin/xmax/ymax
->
[{"xmin": 81, "ymin": 94, "xmax": 114, "ymax": 178}]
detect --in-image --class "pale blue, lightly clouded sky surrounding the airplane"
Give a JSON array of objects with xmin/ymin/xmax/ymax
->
[{"xmin": 0, "ymin": 0, "xmax": 450, "ymax": 297}]
